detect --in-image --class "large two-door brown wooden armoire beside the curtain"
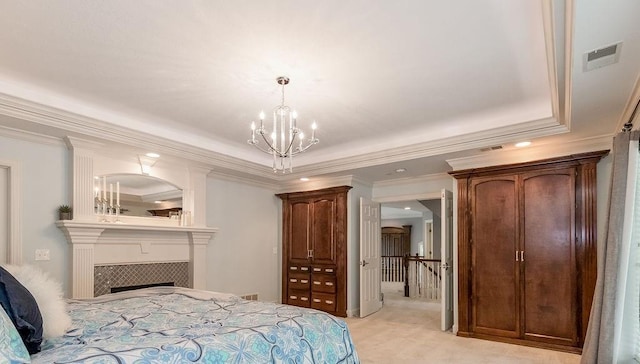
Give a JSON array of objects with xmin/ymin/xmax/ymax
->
[{"xmin": 450, "ymin": 151, "xmax": 608, "ymax": 352}]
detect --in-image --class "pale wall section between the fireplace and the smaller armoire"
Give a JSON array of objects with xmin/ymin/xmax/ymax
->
[{"xmin": 207, "ymin": 177, "xmax": 282, "ymax": 302}]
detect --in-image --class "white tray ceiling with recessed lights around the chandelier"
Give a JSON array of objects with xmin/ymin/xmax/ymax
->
[{"xmin": 0, "ymin": 0, "xmax": 640, "ymax": 183}]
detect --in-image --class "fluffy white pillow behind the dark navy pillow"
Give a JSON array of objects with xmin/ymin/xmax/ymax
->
[{"xmin": 3, "ymin": 265, "xmax": 71, "ymax": 339}]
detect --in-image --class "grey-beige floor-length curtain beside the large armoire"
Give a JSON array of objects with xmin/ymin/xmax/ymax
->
[{"xmin": 581, "ymin": 131, "xmax": 640, "ymax": 364}]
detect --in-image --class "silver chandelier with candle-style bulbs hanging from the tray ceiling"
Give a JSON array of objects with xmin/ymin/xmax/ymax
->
[{"xmin": 247, "ymin": 76, "xmax": 320, "ymax": 173}]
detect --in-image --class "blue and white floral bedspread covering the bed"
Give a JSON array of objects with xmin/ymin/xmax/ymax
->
[{"xmin": 32, "ymin": 287, "xmax": 359, "ymax": 364}]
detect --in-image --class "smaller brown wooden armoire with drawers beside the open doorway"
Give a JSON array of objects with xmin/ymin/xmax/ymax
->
[{"xmin": 277, "ymin": 186, "xmax": 351, "ymax": 317}]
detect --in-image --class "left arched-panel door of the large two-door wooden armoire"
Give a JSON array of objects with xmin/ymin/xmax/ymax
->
[{"xmin": 470, "ymin": 176, "xmax": 520, "ymax": 338}]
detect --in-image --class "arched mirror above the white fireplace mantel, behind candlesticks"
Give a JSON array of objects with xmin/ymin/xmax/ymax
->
[{"xmin": 96, "ymin": 174, "xmax": 182, "ymax": 219}]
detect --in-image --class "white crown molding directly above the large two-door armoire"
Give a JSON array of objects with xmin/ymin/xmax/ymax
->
[{"xmin": 447, "ymin": 135, "xmax": 613, "ymax": 171}]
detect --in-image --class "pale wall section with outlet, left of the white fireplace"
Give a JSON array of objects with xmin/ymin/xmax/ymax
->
[{"xmin": 0, "ymin": 136, "xmax": 71, "ymax": 294}]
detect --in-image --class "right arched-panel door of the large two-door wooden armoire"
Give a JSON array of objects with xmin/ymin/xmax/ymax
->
[{"xmin": 521, "ymin": 168, "xmax": 578, "ymax": 345}]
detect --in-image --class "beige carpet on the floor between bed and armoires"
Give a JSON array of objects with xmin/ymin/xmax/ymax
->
[{"xmin": 346, "ymin": 288, "xmax": 580, "ymax": 364}]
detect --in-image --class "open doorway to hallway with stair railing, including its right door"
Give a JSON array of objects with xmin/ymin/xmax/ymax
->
[{"xmin": 361, "ymin": 189, "xmax": 453, "ymax": 331}]
